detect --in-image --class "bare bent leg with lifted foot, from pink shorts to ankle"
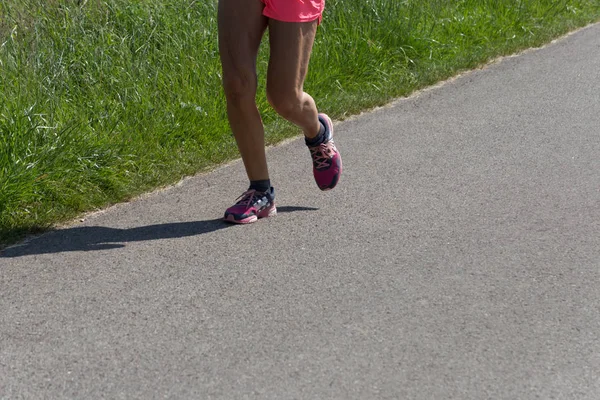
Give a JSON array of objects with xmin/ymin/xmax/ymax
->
[{"xmin": 267, "ymin": 19, "xmax": 320, "ymax": 138}]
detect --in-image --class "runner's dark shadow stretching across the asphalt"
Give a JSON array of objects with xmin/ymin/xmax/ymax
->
[{"xmin": 0, "ymin": 206, "xmax": 318, "ymax": 258}]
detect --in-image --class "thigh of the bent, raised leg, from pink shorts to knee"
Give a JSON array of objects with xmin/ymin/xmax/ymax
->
[{"xmin": 267, "ymin": 19, "xmax": 318, "ymax": 92}]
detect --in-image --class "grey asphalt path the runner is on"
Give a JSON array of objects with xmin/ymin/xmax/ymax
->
[{"xmin": 0, "ymin": 25, "xmax": 600, "ymax": 400}]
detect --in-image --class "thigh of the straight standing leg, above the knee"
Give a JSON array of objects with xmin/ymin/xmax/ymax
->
[{"xmin": 218, "ymin": 0, "xmax": 268, "ymax": 87}]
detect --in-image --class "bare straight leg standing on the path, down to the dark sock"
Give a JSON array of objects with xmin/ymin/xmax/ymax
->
[{"xmin": 218, "ymin": 0, "xmax": 269, "ymax": 181}]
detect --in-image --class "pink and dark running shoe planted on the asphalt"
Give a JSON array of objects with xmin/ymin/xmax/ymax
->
[{"xmin": 223, "ymin": 187, "xmax": 277, "ymax": 224}]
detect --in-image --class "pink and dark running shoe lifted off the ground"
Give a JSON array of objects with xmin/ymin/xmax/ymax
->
[{"xmin": 308, "ymin": 114, "xmax": 342, "ymax": 190}]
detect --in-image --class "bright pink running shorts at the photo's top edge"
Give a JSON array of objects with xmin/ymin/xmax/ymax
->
[{"xmin": 261, "ymin": 0, "xmax": 325, "ymax": 23}]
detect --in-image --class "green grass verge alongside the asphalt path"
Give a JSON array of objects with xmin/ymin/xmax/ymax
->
[{"xmin": 0, "ymin": 0, "xmax": 600, "ymax": 245}]
